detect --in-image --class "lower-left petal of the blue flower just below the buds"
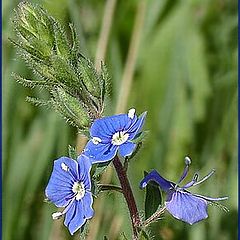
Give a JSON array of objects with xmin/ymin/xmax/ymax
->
[{"xmin": 84, "ymin": 140, "xmax": 118, "ymax": 163}]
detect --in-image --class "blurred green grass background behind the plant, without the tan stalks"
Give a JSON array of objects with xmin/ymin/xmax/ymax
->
[{"xmin": 2, "ymin": 0, "xmax": 238, "ymax": 240}]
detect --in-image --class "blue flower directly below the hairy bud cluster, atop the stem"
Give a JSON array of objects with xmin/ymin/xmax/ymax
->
[{"xmin": 84, "ymin": 109, "xmax": 146, "ymax": 163}]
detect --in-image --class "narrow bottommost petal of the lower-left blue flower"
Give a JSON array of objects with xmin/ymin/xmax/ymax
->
[{"xmin": 68, "ymin": 200, "xmax": 86, "ymax": 235}]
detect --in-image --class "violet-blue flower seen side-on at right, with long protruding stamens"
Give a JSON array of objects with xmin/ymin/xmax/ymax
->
[{"xmin": 140, "ymin": 157, "xmax": 228, "ymax": 225}]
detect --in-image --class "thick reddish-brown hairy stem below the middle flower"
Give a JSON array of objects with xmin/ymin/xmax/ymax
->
[{"xmin": 113, "ymin": 156, "xmax": 140, "ymax": 239}]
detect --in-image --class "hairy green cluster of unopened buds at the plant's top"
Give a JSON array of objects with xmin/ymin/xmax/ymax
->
[{"xmin": 11, "ymin": 2, "xmax": 109, "ymax": 132}]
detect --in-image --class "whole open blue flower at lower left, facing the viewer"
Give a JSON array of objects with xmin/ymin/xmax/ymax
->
[{"xmin": 45, "ymin": 154, "xmax": 94, "ymax": 235}]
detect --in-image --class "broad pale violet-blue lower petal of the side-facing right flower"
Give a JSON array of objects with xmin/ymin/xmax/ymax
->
[{"xmin": 166, "ymin": 191, "xmax": 208, "ymax": 225}]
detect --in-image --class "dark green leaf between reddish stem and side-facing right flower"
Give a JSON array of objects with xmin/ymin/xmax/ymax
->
[{"xmin": 144, "ymin": 171, "xmax": 162, "ymax": 219}]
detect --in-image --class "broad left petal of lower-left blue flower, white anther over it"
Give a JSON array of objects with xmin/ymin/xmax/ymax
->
[{"xmin": 45, "ymin": 157, "xmax": 78, "ymax": 207}]
